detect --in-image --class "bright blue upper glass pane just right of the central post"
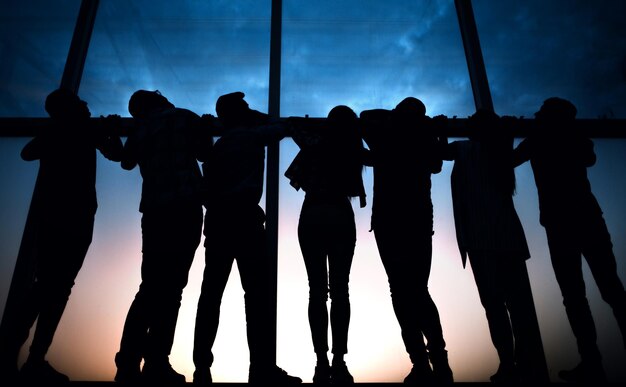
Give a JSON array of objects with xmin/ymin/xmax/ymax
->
[{"xmin": 281, "ymin": 0, "xmax": 474, "ymax": 117}]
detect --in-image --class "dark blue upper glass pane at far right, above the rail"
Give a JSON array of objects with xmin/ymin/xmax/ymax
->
[{"xmin": 472, "ymin": 0, "xmax": 626, "ymax": 118}]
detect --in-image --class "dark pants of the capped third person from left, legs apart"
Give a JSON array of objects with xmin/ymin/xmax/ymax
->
[{"xmin": 193, "ymin": 203, "xmax": 274, "ymax": 368}]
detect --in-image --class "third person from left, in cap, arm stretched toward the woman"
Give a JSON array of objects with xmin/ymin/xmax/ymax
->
[{"xmin": 193, "ymin": 92, "xmax": 302, "ymax": 385}]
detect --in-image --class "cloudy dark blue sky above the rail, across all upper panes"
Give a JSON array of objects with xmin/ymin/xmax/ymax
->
[{"xmin": 0, "ymin": 0, "xmax": 626, "ymax": 118}]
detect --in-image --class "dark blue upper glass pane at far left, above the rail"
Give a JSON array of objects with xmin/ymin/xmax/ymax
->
[{"xmin": 0, "ymin": 0, "xmax": 80, "ymax": 117}]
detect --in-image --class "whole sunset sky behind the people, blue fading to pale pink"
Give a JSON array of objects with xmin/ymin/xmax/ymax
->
[{"xmin": 0, "ymin": 0, "xmax": 626, "ymax": 382}]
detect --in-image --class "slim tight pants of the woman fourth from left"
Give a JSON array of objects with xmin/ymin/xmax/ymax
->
[{"xmin": 298, "ymin": 198, "xmax": 356, "ymax": 355}]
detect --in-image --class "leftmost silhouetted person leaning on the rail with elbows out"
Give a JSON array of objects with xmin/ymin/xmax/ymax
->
[{"xmin": 0, "ymin": 89, "xmax": 122, "ymax": 384}]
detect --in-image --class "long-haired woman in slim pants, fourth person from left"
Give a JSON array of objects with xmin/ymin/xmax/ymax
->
[{"xmin": 285, "ymin": 105, "xmax": 366, "ymax": 384}]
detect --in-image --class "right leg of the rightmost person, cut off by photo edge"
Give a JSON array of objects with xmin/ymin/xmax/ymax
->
[{"xmin": 583, "ymin": 217, "xmax": 626, "ymax": 348}]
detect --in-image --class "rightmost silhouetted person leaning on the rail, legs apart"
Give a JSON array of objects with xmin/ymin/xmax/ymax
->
[{"xmin": 515, "ymin": 97, "xmax": 626, "ymax": 382}]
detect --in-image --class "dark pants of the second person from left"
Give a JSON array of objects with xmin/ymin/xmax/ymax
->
[{"xmin": 116, "ymin": 204, "xmax": 202, "ymax": 367}]
